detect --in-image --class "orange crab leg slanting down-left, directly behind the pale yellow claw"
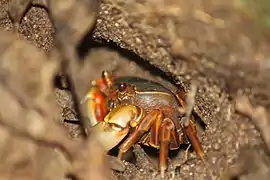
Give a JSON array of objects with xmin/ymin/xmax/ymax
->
[{"xmin": 118, "ymin": 110, "xmax": 161, "ymax": 159}]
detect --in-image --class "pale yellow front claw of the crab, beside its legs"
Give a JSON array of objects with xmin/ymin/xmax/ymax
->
[{"xmin": 90, "ymin": 105, "xmax": 144, "ymax": 152}]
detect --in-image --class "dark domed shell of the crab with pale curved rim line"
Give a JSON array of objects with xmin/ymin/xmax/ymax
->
[{"xmin": 111, "ymin": 77, "xmax": 181, "ymax": 119}]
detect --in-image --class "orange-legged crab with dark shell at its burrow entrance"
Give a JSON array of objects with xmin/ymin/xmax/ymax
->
[{"xmin": 83, "ymin": 71, "xmax": 205, "ymax": 176}]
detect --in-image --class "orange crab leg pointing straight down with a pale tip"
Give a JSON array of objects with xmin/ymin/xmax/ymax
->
[{"xmin": 159, "ymin": 118, "xmax": 174, "ymax": 177}]
